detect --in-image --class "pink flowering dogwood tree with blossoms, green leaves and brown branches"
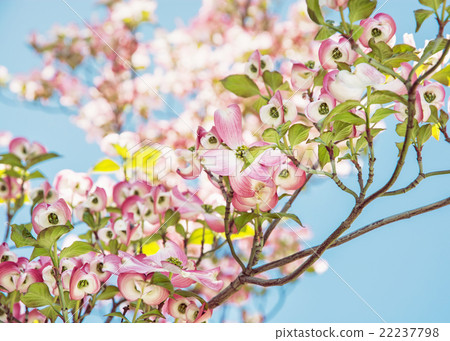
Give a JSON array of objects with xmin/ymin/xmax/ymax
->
[{"xmin": 0, "ymin": 0, "xmax": 450, "ymax": 323}]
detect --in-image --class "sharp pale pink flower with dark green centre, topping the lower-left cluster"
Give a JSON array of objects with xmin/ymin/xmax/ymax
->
[{"xmin": 31, "ymin": 199, "xmax": 72, "ymax": 234}]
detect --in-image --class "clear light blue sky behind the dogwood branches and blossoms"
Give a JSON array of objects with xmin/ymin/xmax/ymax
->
[{"xmin": 0, "ymin": 0, "xmax": 450, "ymax": 322}]
